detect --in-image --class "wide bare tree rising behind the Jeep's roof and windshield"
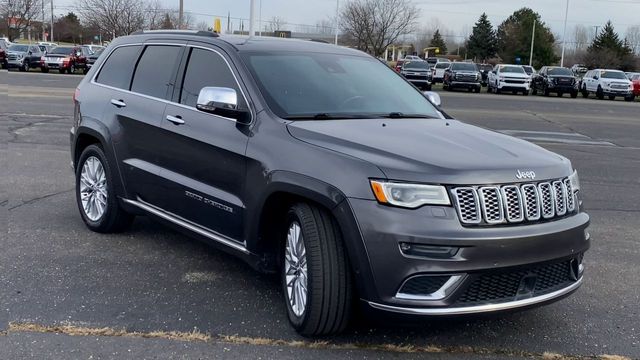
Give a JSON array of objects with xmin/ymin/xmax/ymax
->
[{"xmin": 340, "ymin": 0, "xmax": 420, "ymax": 56}]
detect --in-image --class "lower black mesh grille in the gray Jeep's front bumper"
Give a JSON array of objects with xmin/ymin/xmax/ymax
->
[{"xmin": 456, "ymin": 259, "xmax": 580, "ymax": 306}]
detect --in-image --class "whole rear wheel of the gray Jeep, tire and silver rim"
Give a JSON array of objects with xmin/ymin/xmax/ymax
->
[{"xmin": 76, "ymin": 145, "xmax": 134, "ymax": 233}]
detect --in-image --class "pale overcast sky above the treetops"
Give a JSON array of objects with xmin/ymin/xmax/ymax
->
[{"xmin": 53, "ymin": 0, "xmax": 640, "ymax": 38}]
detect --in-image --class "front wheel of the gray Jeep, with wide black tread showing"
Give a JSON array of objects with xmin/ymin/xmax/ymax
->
[{"xmin": 281, "ymin": 203, "xmax": 353, "ymax": 336}]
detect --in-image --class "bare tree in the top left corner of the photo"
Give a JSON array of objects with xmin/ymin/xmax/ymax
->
[{"xmin": 0, "ymin": 0, "xmax": 42, "ymax": 40}]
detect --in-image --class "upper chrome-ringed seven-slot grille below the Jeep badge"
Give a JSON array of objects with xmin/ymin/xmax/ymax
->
[{"xmin": 451, "ymin": 178, "xmax": 577, "ymax": 225}]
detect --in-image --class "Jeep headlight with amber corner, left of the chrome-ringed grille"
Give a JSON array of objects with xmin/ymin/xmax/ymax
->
[{"xmin": 371, "ymin": 180, "xmax": 451, "ymax": 209}]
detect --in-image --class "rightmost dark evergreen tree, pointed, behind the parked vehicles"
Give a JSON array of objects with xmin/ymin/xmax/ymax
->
[{"xmin": 585, "ymin": 21, "xmax": 634, "ymax": 70}]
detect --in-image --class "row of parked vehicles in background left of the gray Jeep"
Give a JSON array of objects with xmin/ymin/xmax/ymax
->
[{"xmin": 0, "ymin": 39, "xmax": 104, "ymax": 74}]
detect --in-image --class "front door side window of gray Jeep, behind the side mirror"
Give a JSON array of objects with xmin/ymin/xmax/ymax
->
[{"xmin": 180, "ymin": 48, "xmax": 246, "ymax": 108}]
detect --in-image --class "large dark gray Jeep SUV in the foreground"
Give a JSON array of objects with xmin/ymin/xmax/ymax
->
[{"xmin": 70, "ymin": 31, "xmax": 590, "ymax": 335}]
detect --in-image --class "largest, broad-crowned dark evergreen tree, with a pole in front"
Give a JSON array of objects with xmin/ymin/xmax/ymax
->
[{"xmin": 497, "ymin": 7, "xmax": 560, "ymax": 68}]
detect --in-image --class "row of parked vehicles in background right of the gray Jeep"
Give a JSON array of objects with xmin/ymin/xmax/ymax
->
[{"xmin": 395, "ymin": 56, "xmax": 640, "ymax": 101}]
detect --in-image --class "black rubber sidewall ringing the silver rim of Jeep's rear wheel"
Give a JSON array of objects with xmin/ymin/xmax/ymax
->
[{"xmin": 75, "ymin": 145, "xmax": 118, "ymax": 232}]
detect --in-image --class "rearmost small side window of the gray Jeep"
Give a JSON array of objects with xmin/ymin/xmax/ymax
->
[{"xmin": 96, "ymin": 46, "xmax": 140, "ymax": 90}]
